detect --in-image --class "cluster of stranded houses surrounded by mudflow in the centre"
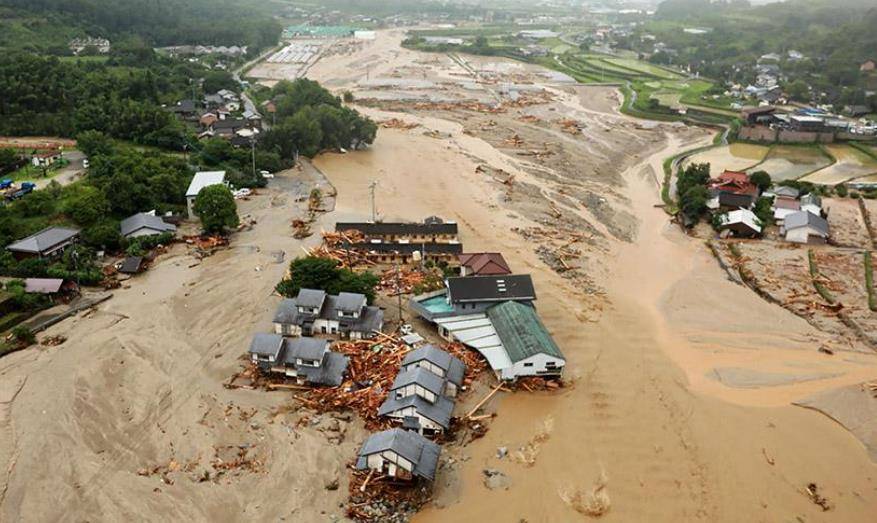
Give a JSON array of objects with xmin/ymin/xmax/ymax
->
[{"xmin": 249, "ymin": 217, "xmax": 566, "ymax": 488}]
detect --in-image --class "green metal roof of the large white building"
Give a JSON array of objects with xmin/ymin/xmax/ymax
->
[{"xmin": 487, "ymin": 301, "xmax": 565, "ymax": 363}]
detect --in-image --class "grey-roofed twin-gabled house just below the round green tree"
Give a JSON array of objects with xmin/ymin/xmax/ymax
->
[{"xmin": 274, "ymin": 289, "xmax": 384, "ymax": 339}]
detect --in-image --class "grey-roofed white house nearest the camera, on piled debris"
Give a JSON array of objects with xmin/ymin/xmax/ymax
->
[{"xmin": 356, "ymin": 429, "xmax": 441, "ymax": 481}]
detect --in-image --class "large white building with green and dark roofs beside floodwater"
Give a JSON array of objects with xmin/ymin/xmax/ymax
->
[{"xmin": 410, "ymin": 275, "xmax": 566, "ymax": 380}]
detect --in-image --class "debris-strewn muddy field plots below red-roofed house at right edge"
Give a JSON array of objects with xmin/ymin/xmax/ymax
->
[{"xmin": 737, "ymin": 242, "xmax": 877, "ymax": 350}]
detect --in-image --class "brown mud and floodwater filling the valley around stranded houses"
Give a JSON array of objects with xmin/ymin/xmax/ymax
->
[{"xmin": 0, "ymin": 29, "xmax": 877, "ymax": 522}]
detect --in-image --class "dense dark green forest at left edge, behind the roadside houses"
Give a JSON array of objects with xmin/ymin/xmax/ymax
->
[{"xmin": 0, "ymin": 49, "xmax": 197, "ymax": 149}]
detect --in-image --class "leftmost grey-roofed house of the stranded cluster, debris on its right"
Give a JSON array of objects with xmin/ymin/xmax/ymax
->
[{"xmin": 249, "ymin": 333, "xmax": 349, "ymax": 387}]
